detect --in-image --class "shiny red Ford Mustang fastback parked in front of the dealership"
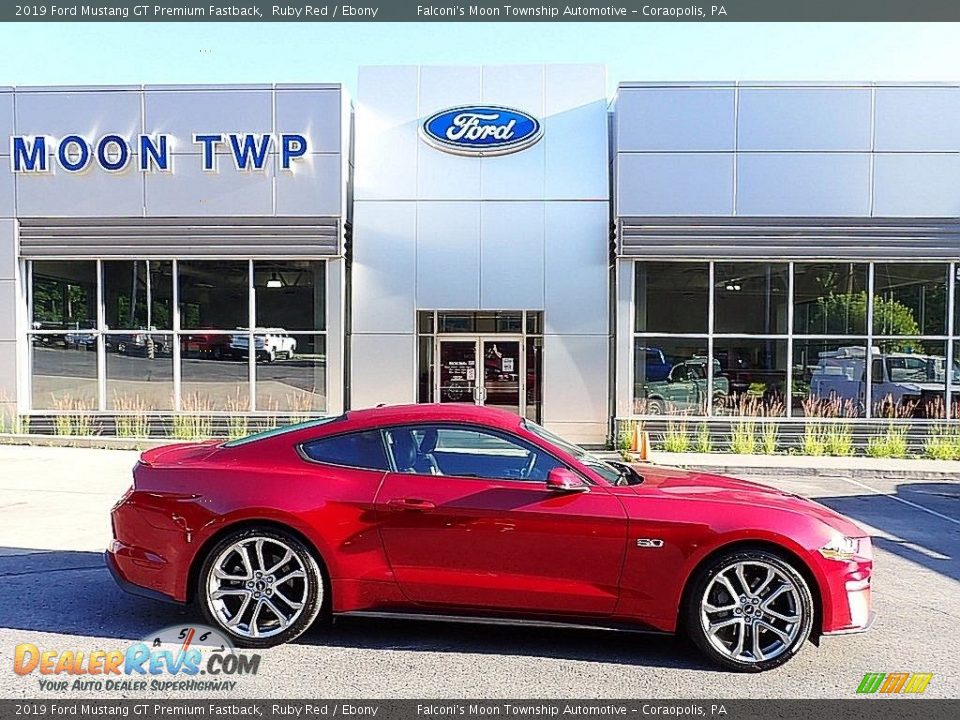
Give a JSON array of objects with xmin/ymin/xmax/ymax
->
[{"xmin": 106, "ymin": 405, "xmax": 873, "ymax": 671}]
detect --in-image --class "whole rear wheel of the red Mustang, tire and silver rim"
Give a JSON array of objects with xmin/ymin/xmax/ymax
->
[{"xmin": 197, "ymin": 528, "xmax": 326, "ymax": 647}]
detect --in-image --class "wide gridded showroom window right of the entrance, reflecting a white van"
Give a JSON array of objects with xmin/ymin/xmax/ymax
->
[{"xmin": 633, "ymin": 261, "xmax": 960, "ymax": 418}]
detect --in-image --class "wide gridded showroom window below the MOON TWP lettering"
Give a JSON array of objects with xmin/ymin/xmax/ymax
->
[{"xmin": 28, "ymin": 260, "xmax": 327, "ymax": 415}]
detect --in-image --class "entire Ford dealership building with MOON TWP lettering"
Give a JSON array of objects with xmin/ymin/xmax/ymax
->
[{"xmin": 0, "ymin": 70, "xmax": 960, "ymax": 444}]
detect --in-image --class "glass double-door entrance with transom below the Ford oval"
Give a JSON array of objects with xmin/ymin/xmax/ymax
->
[{"xmin": 418, "ymin": 311, "xmax": 543, "ymax": 422}]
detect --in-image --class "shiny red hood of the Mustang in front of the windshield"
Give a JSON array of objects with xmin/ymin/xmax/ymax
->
[{"xmin": 631, "ymin": 465, "xmax": 869, "ymax": 537}]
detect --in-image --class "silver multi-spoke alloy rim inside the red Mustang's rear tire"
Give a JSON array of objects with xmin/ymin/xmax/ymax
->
[{"xmin": 206, "ymin": 537, "xmax": 312, "ymax": 638}]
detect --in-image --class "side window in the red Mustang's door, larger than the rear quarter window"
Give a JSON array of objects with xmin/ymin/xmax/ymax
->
[{"xmin": 387, "ymin": 425, "xmax": 563, "ymax": 482}]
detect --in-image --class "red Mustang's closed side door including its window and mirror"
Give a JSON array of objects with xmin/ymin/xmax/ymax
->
[{"xmin": 375, "ymin": 426, "xmax": 627, "ymax": 615}]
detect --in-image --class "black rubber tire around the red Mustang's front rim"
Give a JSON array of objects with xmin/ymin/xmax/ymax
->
[{"xmin": 683, "ymin": 548, "xmax": 816, "ymax": 672}]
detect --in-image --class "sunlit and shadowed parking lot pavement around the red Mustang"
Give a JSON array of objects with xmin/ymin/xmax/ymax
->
[{"xmin": 0, "ymin": 446, "xmax": 960, "ymax": 698}]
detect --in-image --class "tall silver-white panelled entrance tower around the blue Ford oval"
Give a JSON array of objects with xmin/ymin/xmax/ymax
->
[{"xmin": 350, "ymin": 65, "xmax": 610, "ymax": 443}]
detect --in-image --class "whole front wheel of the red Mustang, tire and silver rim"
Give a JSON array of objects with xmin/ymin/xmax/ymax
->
[{"xmin": 685, "ymin": 549, "xmax": 814, "ymax": 672}]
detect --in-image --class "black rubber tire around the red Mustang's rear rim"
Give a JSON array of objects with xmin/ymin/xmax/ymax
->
[{"xmin": 195, "ymin": 527, "xmax": 330, "ymax": 648}]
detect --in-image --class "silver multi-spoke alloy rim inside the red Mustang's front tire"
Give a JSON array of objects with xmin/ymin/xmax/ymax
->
[{"xmin": 700, "ymin": 560, "xmax": 804, "ymax": 663}]
